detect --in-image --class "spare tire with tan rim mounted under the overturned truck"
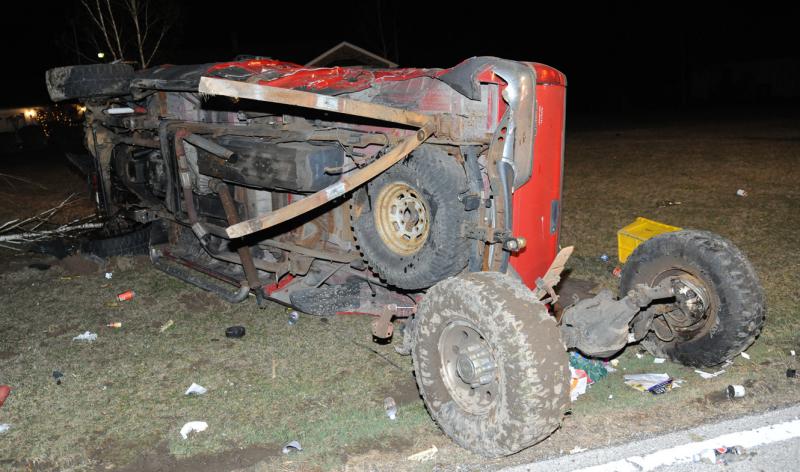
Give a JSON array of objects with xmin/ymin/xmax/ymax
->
[{"xmin": 351, "ymin": 146, "xmax": 477, "ymax": 290}]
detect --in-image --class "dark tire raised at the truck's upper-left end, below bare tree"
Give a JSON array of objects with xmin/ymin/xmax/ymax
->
[{"xmin": 45, "ymin": 64, "xmax": 133, "ymax": 102}]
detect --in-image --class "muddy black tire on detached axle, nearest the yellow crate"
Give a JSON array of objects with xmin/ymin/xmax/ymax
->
[{"xmin": 620, "ymin": 230, "xmax": 766, "ymax": 367}]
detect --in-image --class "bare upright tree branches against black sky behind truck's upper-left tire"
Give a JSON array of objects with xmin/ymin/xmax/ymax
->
[{"xmin": 75, "ymin": 0, "xmax": 178, "ymax": 68}]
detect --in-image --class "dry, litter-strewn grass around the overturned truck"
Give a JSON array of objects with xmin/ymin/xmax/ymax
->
[{"xmin": 0, "ymin": 116, "xmax": 800, "ymax": 471}]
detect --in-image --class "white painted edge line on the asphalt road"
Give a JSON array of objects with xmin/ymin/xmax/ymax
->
[{"xmin": 574, "ymin": 420, "xmax": 800, "ymax": 472}]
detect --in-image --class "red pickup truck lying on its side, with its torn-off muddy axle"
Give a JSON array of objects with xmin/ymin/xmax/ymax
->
[{"xmin": 47, "ymin": 57, "xmax": 765, "ymax": 457}]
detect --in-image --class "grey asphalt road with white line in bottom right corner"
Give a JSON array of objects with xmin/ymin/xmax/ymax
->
[{"xmin": 503, "ymin": 406, "xmax": 800, "ymax": 472}]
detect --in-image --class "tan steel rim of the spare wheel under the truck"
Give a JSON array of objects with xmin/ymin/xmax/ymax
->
[{"xmin": 375, "ymin": 182, "xmax": 430, "ymax": 255}]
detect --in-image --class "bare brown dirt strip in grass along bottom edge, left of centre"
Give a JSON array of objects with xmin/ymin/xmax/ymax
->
[{"xmin": 95, "ymin": 441, "xmax": 281, "ymax": 472}]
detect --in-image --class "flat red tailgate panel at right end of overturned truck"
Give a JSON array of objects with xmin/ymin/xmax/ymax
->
[{"xmin": 510, "ymin": 64, "xmax": 567, "ymax": 288}]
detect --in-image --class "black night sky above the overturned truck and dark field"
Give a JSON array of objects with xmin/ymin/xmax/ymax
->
[{"xmin": 0, "ymin": 1, "xmax": 800, "ymax": 111}]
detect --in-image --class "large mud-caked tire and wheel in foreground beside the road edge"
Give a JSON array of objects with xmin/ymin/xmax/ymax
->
[{"xmin": 412, "ymin": 272, "xmax": 569, "ymax": 457}]
